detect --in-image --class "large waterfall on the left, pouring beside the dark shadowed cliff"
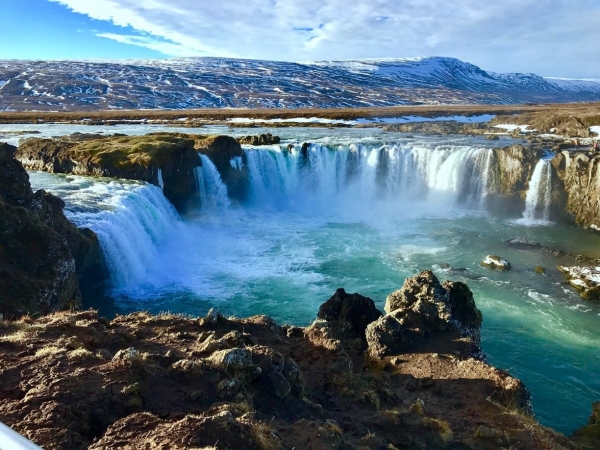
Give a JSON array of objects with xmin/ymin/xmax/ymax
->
[{"xmin": 30, "ymin": 173, "xmax": 180, "ymax": 289}]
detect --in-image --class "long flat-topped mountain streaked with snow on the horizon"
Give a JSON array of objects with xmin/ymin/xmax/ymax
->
[{"xmin": 0, "ymin": 57, "xmax": 600, "ymax": 111}]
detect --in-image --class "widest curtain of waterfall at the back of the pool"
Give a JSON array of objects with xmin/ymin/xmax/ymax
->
[{"xmin": 244, "ymin": 144, "xmax": 493, "ymax": 213}]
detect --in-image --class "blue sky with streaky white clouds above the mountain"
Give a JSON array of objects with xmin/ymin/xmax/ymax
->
[{"xmin": 0, "ymin": 0, "xmax": 600, "ymax": 78}]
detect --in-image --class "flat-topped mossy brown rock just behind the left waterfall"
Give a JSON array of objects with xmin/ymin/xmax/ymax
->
[{"xmin": 16, "ymin": 133, "xmax": 201, "ymax": 213}]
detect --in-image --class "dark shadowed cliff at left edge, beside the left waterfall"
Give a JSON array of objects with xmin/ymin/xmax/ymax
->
[{"xmin": 0, "ymin": 144, "xmax": 106, "ymax": 318}]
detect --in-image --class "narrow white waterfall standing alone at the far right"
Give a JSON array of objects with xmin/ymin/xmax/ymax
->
[{"xmin": 523, "ymin": 159, "xmax": 552, "ymax": 224}]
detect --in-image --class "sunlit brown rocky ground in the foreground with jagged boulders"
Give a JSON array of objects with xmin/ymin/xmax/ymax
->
[{"xmin": 0, "ymin": 282, "xmax": 574, "ymax": 450}]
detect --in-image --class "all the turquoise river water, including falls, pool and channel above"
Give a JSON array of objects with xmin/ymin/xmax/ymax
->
[{"xmin": 9, "ymin": 125, "xmax": 600, "ymax": 433}]
